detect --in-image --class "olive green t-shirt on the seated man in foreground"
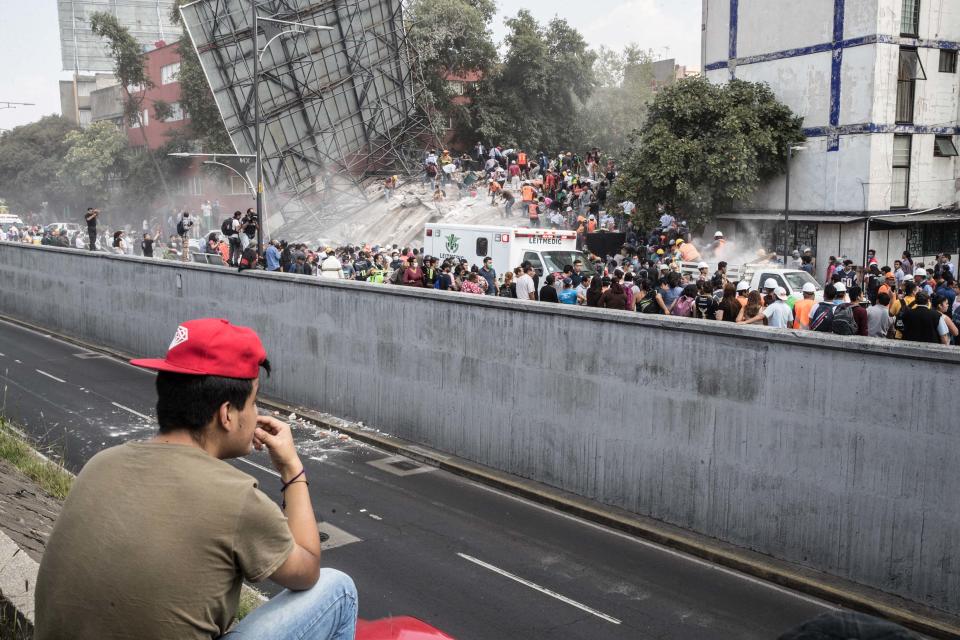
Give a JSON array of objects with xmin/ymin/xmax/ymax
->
[{"xmin": 34, "ymin": 442, "xmax": 294, "ymax": 640}]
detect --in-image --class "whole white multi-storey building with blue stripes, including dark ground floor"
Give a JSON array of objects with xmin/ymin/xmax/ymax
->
[{"xmin": 702, "ymin": 0, "xmax": 960, "ymax": 274}]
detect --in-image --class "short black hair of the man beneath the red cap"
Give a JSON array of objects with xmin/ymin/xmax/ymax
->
[{"xmin": 156, "ymin": 360, "xmax": 270, "ymax": 440}]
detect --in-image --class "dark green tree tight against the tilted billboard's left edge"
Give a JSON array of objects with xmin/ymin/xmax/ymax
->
[{"xmin": 170, "ymin": 0, "xmax": 233, "ymax": 153}]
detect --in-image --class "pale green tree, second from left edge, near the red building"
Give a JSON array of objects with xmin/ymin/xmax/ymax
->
[{"xmin": 57, "ymin": 122, "xmax": 127, "ymax": 203}]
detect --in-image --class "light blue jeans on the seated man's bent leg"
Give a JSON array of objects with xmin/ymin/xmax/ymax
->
[{"xmin": 223, "ymin": 569, "xmax": 357, "ymax": 640}]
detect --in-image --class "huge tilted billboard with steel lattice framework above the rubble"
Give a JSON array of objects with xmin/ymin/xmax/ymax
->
[{"xmin": 181, "ymin": 0, "xmax": 436, "ymax": 233}]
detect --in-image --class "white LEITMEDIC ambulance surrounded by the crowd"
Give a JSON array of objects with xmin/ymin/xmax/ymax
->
[{"xmin": 423, "ymin": 222, "xmax": 593, "ymax": 276}]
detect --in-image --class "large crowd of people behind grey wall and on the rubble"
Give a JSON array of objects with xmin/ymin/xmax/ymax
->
[{"xmin": 0, "ymin": 143, "xmax": 960, "ymax": 345}]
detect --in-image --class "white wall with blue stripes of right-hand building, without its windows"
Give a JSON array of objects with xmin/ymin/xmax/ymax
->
[{"xmin": 704, "ymin": 0, "xmax": 960, "ymax": 220}]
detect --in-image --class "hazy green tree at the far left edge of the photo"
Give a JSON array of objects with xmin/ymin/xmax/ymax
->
[{"xmin": 0, "ymin": 116, "xmax": 76, "ymax": 213}]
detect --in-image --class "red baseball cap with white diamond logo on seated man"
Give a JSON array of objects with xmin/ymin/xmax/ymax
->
[{"xmin": 130, "ymin": 318, "xmax": 267, "ymax": 380}]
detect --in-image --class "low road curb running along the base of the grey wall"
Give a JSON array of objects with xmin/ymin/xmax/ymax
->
[{"xmin": 0, "ymin": 314, "xmax": 960, "ymax": 639}]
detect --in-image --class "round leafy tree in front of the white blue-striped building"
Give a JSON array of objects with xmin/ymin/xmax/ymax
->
[{"xmin": 611, "ymin": 78, "xmax": 804, "ymax": 226}]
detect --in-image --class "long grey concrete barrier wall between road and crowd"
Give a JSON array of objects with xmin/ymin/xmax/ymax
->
[{"xmin": 0, "ymin": 243, "xmax": 960, "ymax": 613}]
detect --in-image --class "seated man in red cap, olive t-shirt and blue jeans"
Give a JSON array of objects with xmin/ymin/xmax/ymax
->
[{"xmin": 34, "ymin": 319, "xmax": 357, "ymax": 640}]
